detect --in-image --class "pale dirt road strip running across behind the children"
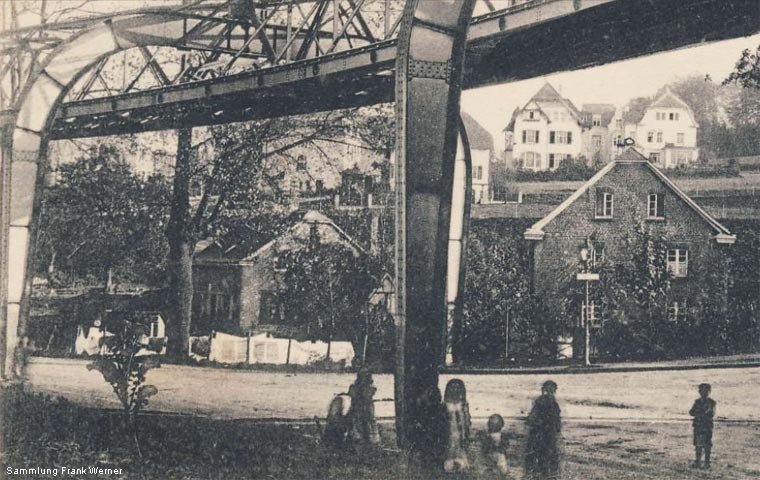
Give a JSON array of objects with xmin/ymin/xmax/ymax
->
[{"xmin": 27, "ymin": 358, "xmax": 760, "ymax": 421}]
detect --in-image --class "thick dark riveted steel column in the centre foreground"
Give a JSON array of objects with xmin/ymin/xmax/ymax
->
[{"xmin": 395, "ymin": 0, "xmax": 475, "ymax": 452}]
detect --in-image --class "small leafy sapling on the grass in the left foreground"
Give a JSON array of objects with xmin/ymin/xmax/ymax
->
[{"xmin": 87, "ymin": 321, "xmax": 159, "ymax": 458}]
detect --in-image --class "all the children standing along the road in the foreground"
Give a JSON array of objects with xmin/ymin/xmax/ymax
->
[{"xmin": 324, "ymin": 372, "xmax": 716, "ymax": 479}]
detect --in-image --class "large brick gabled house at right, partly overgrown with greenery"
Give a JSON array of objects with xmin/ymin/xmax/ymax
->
[{"xmin": 524, "ymin": 148, "xmax": 736, "ymax": 346}]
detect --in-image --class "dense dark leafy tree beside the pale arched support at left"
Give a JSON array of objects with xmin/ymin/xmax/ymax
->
[{"xmin": 35, "ymin": 145, "xmax": 169, "ymax": 285}]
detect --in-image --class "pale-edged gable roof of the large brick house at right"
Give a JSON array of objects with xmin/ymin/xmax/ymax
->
[{"xmin": 524, "ymin": 148, "xmax": 736, "ymax": 244}]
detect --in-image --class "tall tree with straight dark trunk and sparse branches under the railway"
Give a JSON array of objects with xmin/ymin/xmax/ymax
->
[{"xmin": 167, "ymin": 109, "xmax": 382, "ymax": 359}]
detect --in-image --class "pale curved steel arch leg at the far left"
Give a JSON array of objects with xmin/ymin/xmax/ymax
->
[{"xmin": 0, "ymin": 11, "xmax": 258, "ymax": 376}]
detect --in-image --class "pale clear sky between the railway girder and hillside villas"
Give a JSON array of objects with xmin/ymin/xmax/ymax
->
[{"xmin": 462, "ymin": 35, "xmax": 760, "ymax": 154}]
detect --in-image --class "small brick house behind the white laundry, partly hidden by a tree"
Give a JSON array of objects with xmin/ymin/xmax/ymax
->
[{"xmin": 192, "ymin": 210, "xmax": 366, "ymax": 335}]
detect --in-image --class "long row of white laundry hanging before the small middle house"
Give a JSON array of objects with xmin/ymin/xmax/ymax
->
[{"xmin": 208, "ymin": 332, "xmax": 354, "ymax": 366}]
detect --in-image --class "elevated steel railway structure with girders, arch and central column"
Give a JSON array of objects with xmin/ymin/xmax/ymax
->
[{"xmin": 0, "ymin": 0, "xmax": 760, "ymax": 449}]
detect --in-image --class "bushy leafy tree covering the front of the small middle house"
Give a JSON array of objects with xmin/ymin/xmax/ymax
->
[{"xmin": 279, "ymin": 228, "xmax": 375, "ymax": 359}]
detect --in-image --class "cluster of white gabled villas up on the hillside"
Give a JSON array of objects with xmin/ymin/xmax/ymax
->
[{"xmin": 503, "ymin": 83, "xmax": 699, "ymax": 171}]
